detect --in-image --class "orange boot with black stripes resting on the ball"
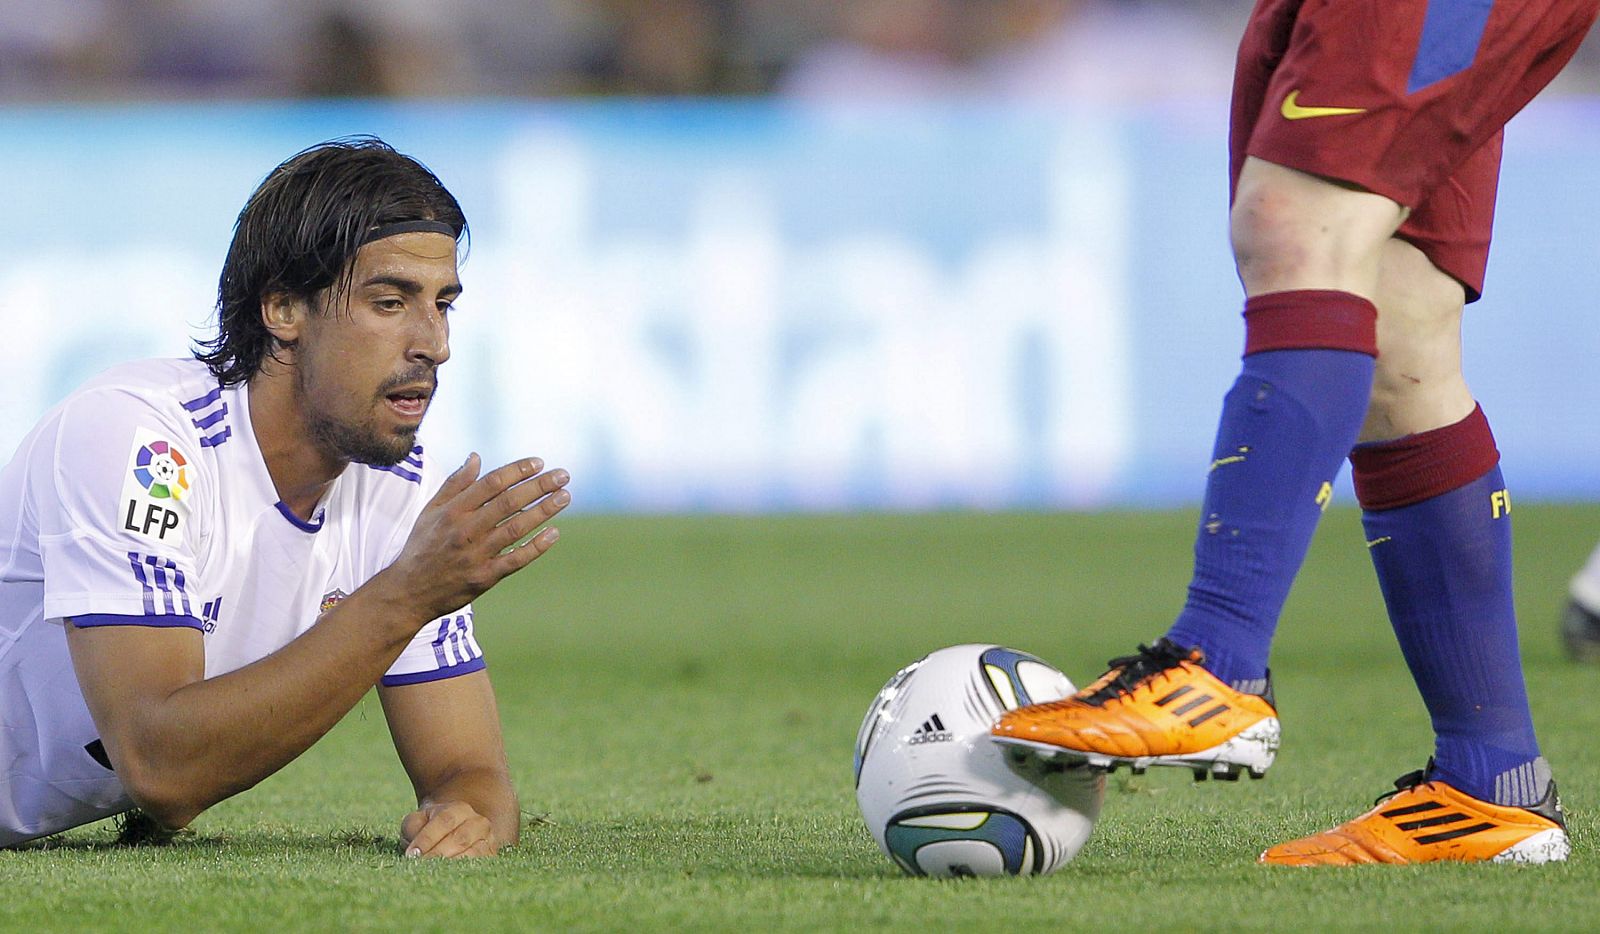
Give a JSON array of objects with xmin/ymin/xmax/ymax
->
[{"xmin": 990, "ymin": 638, "xmax": 1278, "ymax": 780}]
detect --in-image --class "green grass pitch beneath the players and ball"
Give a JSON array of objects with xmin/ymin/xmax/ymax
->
[{"xmin": 0, "ymin": 504, "xmax": 1600, "ymax": 931}]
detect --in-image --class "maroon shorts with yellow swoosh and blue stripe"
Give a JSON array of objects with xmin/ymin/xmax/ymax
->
[{"xmin": 1229, "ymin": 0, "xmax": 1600, "ymax": 301}]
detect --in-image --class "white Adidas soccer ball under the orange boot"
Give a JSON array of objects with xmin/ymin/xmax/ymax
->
[{"xmin": 856, "ymin": 645, "xmax": 1106, "ymax": 876}]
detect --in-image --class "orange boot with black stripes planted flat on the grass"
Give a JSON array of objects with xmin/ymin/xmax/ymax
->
[{"xmin": 1261, "ymin": 763, "xmax": 1571, "ymax": 865}]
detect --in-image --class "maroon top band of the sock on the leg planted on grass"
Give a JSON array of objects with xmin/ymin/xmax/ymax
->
[{"xmin": 1350, "ymin": 406, "xmax": 1499, "ymax": 512}]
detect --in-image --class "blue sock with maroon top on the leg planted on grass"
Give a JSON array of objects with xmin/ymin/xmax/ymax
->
[{"xmin": 1350, "ymin": 411, "xmax": 1550, "ymax": 806}]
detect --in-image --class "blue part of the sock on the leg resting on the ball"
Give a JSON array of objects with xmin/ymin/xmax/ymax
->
[{"xmin": 1166, "ymin": 349, "xmax": 1374, "ymax": 691}]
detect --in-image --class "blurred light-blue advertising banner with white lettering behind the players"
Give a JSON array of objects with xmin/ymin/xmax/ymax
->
[{"xmin": 0, "ymin": 101, "xmax": 1600, "ymax": 510}]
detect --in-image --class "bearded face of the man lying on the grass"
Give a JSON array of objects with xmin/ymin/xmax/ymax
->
[{"xmin": 294, "ymin": 232, "xmax": 461, "ymax": 467}]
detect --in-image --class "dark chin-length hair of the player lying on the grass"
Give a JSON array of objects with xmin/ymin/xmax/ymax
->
[{"xmin": 195, "ymin": 136, "xmax": 467, "ymax": 385}]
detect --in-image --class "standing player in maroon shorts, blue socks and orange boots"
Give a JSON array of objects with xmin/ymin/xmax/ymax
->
[{"xmin": 995, "ymin": 0, "xmax": 1600, "ymax": 865}]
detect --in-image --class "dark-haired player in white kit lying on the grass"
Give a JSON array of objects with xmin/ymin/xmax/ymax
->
[{"xmin": 0, "ymin": 139, "xmax": 570, "ymax": 856}]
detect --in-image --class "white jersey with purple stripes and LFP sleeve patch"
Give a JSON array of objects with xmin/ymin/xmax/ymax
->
[{"xmin": 0, "ymin": 360, "xmax": 483, "ymax": 846}]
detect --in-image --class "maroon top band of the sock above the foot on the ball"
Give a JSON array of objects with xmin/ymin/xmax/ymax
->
[{"xmin": 1245, "ymin": 289, "xmax": 1378, "ymax": 357}]
